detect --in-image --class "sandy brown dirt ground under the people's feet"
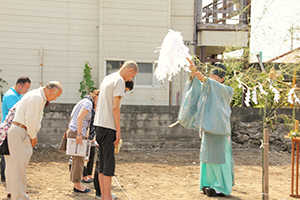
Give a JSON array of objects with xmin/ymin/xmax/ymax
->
[{"xmin": 0, "ymin": 141, "xmax": 294, "ymax": 200}]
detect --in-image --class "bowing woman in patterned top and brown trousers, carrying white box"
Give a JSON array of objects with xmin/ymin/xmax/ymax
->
[{"xmin": 67, "ymin": 90, "xmax": 99, "ymax": 193}]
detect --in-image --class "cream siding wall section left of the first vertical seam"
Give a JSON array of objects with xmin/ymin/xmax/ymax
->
[{"xmin": 0, "ymin": 0, "xmax": 98, "ymax": 103}]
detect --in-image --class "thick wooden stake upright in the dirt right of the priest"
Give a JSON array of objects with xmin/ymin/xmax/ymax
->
[{"xmin": 263, "ymin": 128, "xmax": 269, "ymax": 200}]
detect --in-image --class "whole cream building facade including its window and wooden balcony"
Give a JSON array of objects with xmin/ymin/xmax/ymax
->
[{"xmin": 0, "ymin": 0, "xmax": 247, "ymax": 106}]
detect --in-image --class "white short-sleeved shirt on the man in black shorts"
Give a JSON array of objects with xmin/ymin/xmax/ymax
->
[{"xmin": 94, "ymin": 72, "xmax": 125, "ymax": 130}]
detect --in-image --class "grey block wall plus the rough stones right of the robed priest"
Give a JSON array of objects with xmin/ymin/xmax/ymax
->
[{"xmin": 38, "ymin": 103, "xmax": 300, "ymax": 151}]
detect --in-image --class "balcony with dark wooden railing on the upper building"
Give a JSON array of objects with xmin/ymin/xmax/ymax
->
[{"xmin": 195, "ymin": 0, "xmax": 250, "ymax": 62}]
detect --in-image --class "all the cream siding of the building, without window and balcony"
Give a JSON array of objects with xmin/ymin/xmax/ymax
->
[{"xmin": 0, "ymin": 0, "xmax": 194, "ymax": 105}]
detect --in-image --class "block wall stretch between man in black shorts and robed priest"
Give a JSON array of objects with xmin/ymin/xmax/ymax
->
[{"xmin": 121, "ymin": 106, "xmax": 198, "ymax": 142}]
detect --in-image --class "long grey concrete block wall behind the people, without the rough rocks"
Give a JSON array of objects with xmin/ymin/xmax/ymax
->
[{"xmin": 38, "ymin": 103, "xmax": 300, "ymax": 145}]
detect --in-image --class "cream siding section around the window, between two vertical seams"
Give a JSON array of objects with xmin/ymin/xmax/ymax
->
[{"xmin": 99, "ymin": 0, "xmax": 170, "ymax": 105}]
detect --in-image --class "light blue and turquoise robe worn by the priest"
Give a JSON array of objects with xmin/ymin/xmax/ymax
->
[{"xmin": 178, "ymin": 78, "xmax": 234, "ymax": 195}]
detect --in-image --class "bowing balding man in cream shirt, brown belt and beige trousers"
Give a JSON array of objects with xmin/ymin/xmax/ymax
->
[{"xmin": 6, "ymin": 81, "xmax": 63, "ymax": 200}]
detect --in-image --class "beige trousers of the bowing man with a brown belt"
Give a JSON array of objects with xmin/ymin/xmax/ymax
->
[{"xmin": 7, "ymin": 125, "xmax": 32, "ymax": 200}]
